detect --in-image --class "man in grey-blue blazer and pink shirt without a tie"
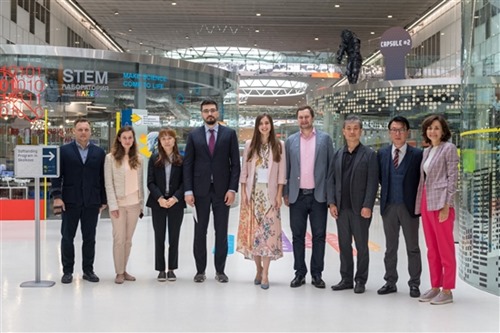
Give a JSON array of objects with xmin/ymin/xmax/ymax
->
[{"xmin": 283, "ymin": 106, "xmax": 333, "ymax": 288}]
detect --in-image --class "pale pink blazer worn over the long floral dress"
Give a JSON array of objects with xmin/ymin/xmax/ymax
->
[{"xmin": 240, "ymin": 140, "xmax": 286, "ymax": 200}]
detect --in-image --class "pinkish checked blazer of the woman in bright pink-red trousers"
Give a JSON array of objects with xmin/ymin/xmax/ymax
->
[{"xmin": 415, "ymin": 142, "xmax": 458, "ymax": 214}]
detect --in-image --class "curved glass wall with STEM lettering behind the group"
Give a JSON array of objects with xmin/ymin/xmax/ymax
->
[{"xmin": 0, "ymin": 45, "xmax": 238, "ymax": 214}]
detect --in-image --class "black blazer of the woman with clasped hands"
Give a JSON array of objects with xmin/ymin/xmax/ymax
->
[{"xmin": 146, "ymin": 153, "xmax": 186, "ymax": 208}]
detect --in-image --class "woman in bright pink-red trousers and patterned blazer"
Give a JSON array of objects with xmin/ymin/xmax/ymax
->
[{"xmin": 415, "ymin": 115, "xmax": 458, "ymax": 304}]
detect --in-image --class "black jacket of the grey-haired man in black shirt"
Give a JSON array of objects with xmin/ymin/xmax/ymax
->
[{"xmin": 333, "ymin": 143, "xmax": 378, "ymax": 214}]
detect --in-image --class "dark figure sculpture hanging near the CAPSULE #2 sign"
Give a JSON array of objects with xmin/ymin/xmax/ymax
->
[{"xmin": 337, "ymin": 30, "xmax": 363, "ymax": 83}]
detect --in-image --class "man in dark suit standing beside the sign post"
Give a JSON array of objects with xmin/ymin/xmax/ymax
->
[{"xmin": 51, "ymin": 118, "xmax": 106, "ymax": 283}]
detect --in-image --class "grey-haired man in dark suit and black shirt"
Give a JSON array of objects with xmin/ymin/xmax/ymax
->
[{"xmin": 330, "ymin": 115, "xmax": 378, "ymax": 294}]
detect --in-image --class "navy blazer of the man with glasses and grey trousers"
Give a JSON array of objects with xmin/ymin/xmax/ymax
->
[{"xmin": 377, "ymin": 144, "xmax": 422, "ymax": 217}]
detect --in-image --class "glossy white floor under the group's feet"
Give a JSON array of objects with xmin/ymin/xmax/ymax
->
[{"xmin": 0, "ymin": 208, "xmax": 500, "ymax": 332}]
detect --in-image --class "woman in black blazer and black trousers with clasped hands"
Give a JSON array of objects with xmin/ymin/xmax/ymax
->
[{"xmin": 146, "ymin": 129, "xmax": 186, "ymax": 282}]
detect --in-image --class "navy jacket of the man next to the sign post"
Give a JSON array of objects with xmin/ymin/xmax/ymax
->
[{"xmin": 51, "ymin": 141, "xmax": 107, "ymax": 207}]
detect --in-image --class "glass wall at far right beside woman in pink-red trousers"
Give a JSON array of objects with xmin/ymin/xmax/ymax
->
[{"xmin": 459, "ymin": 0, "xmax": 500, "ymax": 295}]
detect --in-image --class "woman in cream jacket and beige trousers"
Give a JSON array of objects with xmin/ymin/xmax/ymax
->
[{"xmin": 104, "ymin": 126, "xmax": 144, "ymax": 284}]
